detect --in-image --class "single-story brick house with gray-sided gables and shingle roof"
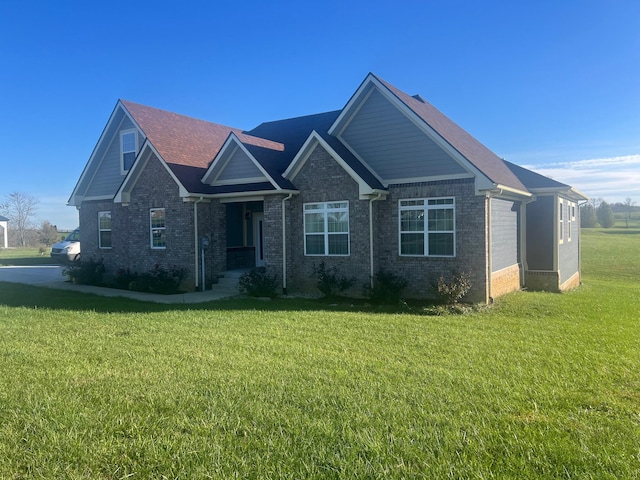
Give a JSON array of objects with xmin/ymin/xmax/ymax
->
[{"xmin": 69, "ymin": 74, "xmax": 586, "ymax": 302}]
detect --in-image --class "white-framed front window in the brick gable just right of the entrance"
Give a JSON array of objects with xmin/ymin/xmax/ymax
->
[{"xmin": 304, "ymin": 202, "xmax": 349, "ymax": 255}]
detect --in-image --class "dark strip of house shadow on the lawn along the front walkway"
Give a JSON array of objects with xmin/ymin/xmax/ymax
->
[{"xmin": 0, "ymin": 282, "xmax": 436, "ymax": 314}]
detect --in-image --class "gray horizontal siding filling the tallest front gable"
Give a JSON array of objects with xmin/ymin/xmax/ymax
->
[{"xmin": 342, "ymin": 90, "xmax": 465, "ymax": 180}]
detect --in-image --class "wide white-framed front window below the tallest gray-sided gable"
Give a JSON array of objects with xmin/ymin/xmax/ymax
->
[{"xmin": 399, "ymin": 198, "xmax": 456, "ymax": 257}]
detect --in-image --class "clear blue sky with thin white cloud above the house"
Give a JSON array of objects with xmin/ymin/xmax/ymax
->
[{"xmin": 0, "ymin": 0, "xmax": 640, "ymax": 228}]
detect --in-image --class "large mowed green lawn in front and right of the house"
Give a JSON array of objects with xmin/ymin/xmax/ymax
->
[{"xmin": 0, "ymin": 230, "xmax": 640, "ymax": 479}]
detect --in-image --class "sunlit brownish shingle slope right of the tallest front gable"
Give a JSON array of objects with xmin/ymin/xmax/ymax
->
[{"xmin": 373, "ymin": 75, "xmax": 527, "ymax": 192}]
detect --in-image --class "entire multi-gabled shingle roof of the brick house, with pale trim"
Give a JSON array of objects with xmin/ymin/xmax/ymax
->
[{"xmin": 72, "ymin": 73, "xmax": 584, "ymax": 201}]
